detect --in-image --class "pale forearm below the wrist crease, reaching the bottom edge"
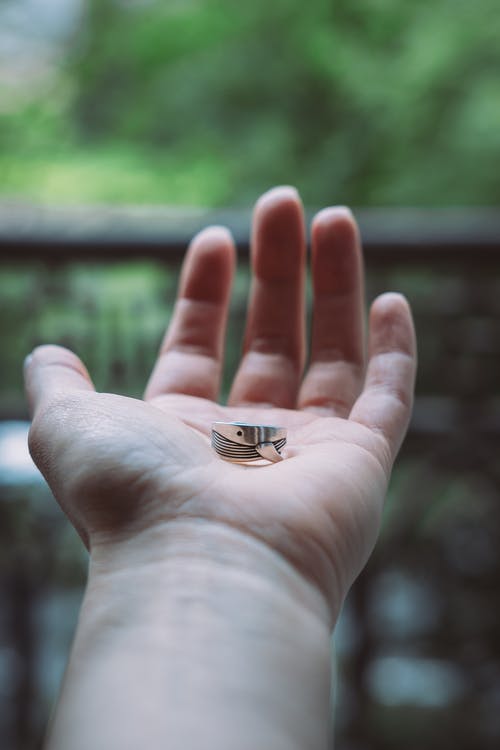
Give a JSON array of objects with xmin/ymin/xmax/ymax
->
[{"xmin": 47, "ymin": 522, "xmax": 331, "ymax": 750}]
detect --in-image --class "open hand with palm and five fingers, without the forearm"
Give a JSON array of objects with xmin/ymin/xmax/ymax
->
[{"xmin": 25, "ymin": 188, "xmax": 415, "ymax": 624}]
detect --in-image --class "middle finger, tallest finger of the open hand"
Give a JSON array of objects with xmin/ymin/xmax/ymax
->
[{"xmin": 229, "ymin": 187, "xmax": 306, "ymax": 407}]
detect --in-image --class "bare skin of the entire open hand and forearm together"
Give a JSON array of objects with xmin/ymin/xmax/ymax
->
[{"xmin": 25, "ymin": 187, "xmax": 416, "ymax": 750}]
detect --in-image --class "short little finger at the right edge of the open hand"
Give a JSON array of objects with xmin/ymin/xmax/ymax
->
[{"xmin": 349, "ymin": 293, "xmax": 416, "ymax": 462}]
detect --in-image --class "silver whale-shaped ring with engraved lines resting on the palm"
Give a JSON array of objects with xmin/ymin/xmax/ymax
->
[{"xmin": 212, "ymin": 422, "xmax": 286, "ymax": 463}]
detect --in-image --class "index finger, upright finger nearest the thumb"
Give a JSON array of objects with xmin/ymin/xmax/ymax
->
[{"xmin": 145, "ymin": 226, "xmax": 235, "ymax": 399}]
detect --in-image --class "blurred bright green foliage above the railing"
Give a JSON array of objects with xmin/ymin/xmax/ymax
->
[{"xmin": 0, "ymin": 0, "xmax": 500, "ymax": 206}]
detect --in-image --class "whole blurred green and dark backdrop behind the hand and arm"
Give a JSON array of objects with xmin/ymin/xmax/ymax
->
[{"xmin": 0, "ymin": 0, "xmax": 500, "ymax": 750}]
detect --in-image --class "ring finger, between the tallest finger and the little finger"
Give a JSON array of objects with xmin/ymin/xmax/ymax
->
[{"xmin": 299, "ymin": 207, "xmax": 364, "ymax": 417}]
